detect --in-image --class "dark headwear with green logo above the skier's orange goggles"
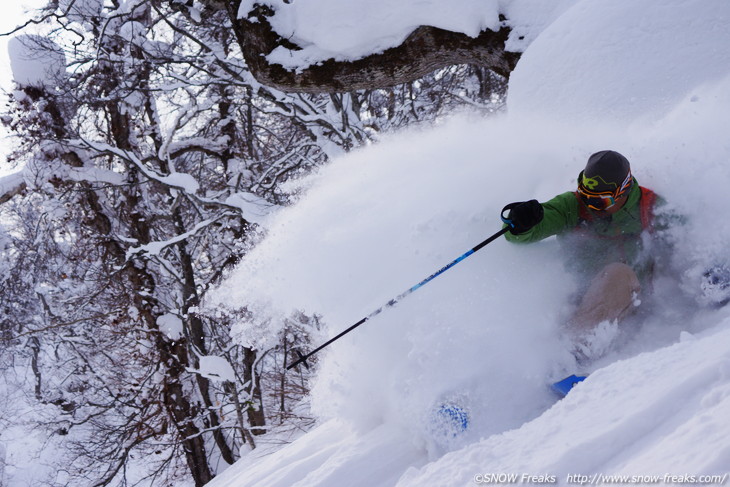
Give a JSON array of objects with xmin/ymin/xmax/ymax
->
[{"xmin": 578, "ymin": 150, "xmax": 631, "ymax": 194}]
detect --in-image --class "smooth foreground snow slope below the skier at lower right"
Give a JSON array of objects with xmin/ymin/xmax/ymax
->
[{"xmin": 398, "ymin": 320, "xmax": 730, "ymax": 487}]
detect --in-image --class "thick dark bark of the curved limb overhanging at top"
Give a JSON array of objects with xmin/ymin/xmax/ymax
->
[{"xmin": 226, "ymin": 0, "xmax": 520, "ymax": 93}]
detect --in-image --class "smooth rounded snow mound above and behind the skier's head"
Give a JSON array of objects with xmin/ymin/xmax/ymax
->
[{"xmin": 509, "ymin": 0, "xmax": 730, "ymax": 121}]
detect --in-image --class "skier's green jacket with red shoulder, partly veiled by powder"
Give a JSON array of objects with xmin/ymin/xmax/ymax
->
[{"xmin": 505, "ymin": 180, "xmax": 652, "ymax": 280}]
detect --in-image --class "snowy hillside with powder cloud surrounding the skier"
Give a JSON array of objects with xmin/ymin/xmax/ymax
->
[{"xmin": 203, "ymin": 0, "xmax": 730, "ymax": 487}]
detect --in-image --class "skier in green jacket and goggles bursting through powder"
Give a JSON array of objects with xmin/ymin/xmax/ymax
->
[{"xmin": 503, "ymin": 150, "xmax": 658, "ymax": 358}]
